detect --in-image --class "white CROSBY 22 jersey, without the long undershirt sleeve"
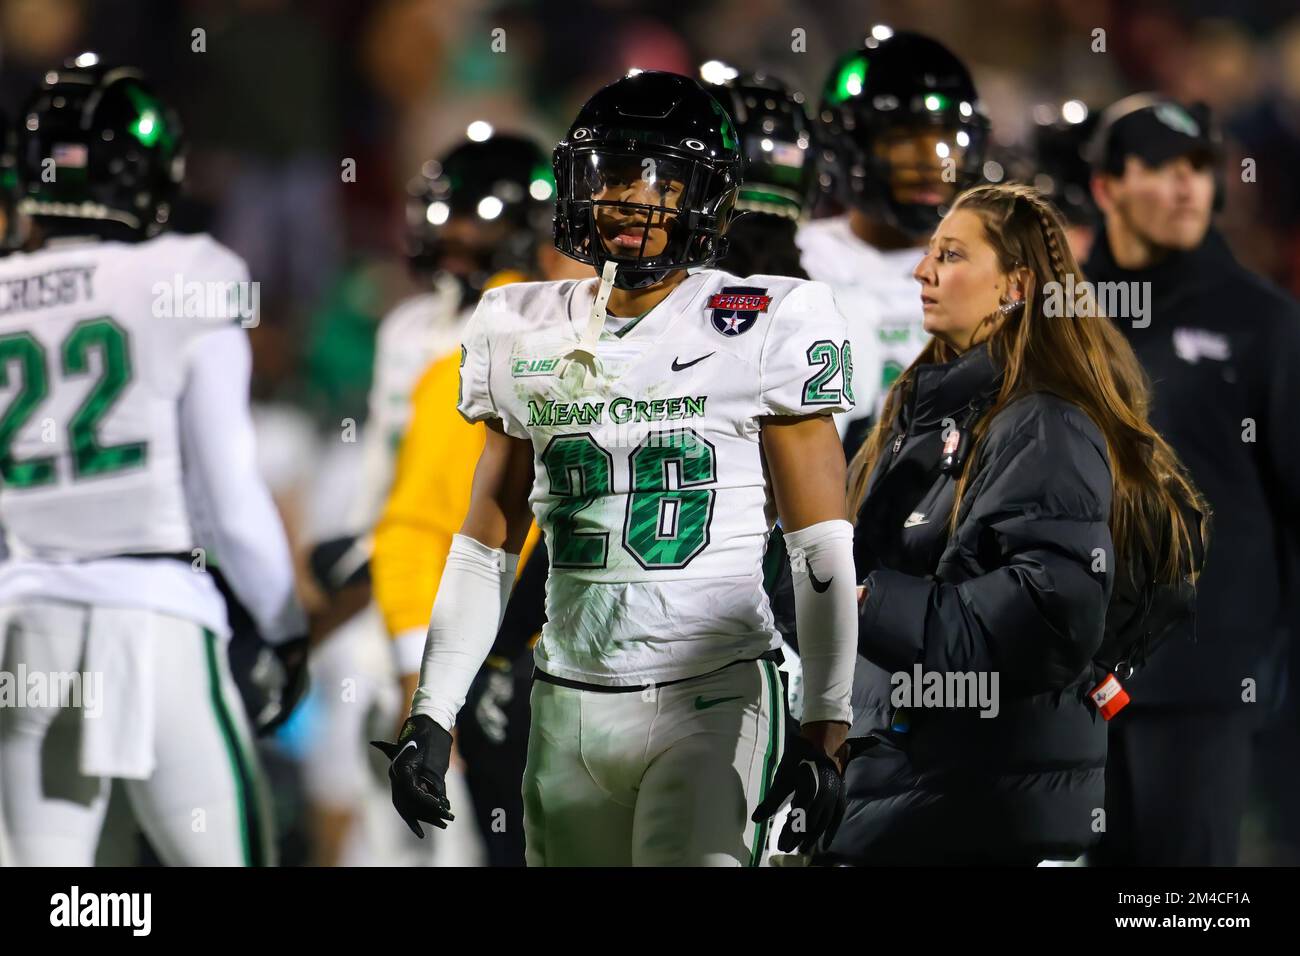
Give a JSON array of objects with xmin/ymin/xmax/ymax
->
[{"xmin": 0, "ymin": 235, "xmax": 236, "ymax": 561}]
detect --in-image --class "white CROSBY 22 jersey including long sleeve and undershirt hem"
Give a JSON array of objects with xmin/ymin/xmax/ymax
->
[{"xmin": 0, "ymin": 234, "xmax": 304, "ymax": 641}]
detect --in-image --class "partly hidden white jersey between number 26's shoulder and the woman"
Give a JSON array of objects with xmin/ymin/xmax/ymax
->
[{"xmin": 796, "ymin": 215, "xmax": 930, "ymax": 431}]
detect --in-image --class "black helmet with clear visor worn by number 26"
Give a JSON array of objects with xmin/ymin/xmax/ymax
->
[{"xmin": 553, "ymin": 70, "xmax": 742, "ymax": 289}]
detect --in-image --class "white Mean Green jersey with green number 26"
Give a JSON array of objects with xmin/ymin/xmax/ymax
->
[{"xmin": 460, "ymin": 269, "xmax": 853, "ymax": 685}]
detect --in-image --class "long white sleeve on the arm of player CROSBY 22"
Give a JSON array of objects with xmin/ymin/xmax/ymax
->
[{"xmin": 179, "ymin": 325, "xmax": 307, "ymax": 644}]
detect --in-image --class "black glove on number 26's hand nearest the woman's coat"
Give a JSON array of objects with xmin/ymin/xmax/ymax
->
[{"xmin": 753, "ymin": 734, "xmax": 844, "ymax": 853}]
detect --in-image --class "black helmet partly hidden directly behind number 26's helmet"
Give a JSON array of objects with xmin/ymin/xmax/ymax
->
[{"xmin": 711, "ymin": 73, "xmax": 816, "ymax": 219}]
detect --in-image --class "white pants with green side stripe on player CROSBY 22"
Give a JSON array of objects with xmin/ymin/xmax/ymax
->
[{"xmin": 0, "ymin": 601, "xmax": 274, "ymax": 866}]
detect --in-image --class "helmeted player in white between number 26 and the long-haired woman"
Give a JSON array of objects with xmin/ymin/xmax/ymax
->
[{"xmin": 798, "ymin": 30, "xmax": 988, "ymax": 457}]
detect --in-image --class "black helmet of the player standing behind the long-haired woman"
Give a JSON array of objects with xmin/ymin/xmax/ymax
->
[{"xmin": 819, "ymin": 33, "xmax": 989, "ymax": 238}]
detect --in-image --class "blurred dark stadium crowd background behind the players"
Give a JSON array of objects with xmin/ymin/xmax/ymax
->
[{"xmin": 0, "ymin": 0, "xmax": 1300, "ymax": 864}]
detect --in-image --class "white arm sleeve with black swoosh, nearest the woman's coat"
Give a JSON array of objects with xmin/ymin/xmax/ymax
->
[{"xmin": 785, "ymin": 519, "xmax": 858, "ymax": 723}]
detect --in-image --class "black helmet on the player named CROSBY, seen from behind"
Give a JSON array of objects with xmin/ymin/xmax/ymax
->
[{"xmin": 18, "ymin": 55, "xmax": 185, "ymax": 239}]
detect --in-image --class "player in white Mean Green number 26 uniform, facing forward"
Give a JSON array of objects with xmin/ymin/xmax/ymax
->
[{"xmin": 382, "ymin": 72, "xmax": 857, "ymax": 865}]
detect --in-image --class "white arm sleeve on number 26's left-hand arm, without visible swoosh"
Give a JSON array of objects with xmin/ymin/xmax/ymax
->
[{"xmin": 411, "ymin": 535, "xmax": 519, "ymax": 732}]
